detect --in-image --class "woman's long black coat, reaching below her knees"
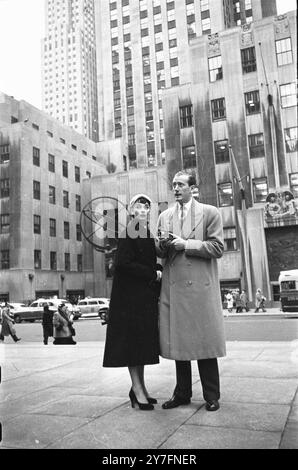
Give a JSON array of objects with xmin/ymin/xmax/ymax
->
[{"xmin": 103, "ymin": 222, "xmax": 159, "ymax": 367}]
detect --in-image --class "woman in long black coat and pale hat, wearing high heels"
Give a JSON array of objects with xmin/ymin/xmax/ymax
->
[{"xmin": 103, "ymin": 194, "xmax": 161, "ymax": 410}]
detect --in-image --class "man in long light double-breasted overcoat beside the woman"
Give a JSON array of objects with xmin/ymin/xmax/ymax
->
[{"xmin": 157, "ymin": 171, "xmax": 226, "ymax": 411}]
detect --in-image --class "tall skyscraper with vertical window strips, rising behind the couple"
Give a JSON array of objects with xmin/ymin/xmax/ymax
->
[{"xmin": 95, "ymin": 0, "xmax": 276, "ymax": 169}]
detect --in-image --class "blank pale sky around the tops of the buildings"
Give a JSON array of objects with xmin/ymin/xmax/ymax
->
[{"xmin": 0, "ymin": 0, "xmax": 296, "ymax": 108}]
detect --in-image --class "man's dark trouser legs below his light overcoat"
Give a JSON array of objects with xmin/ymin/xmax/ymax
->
[{"xmin": 174, "ymin": 358, "xmax": 220, "ymax": 402}]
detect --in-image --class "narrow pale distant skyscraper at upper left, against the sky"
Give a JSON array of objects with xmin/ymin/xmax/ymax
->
[{"xmin": 42, "ymin": 0, "xmax": 98, "ymax": 142}]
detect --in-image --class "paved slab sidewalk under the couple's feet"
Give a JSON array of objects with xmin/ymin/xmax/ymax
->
[{"xmin": 0, "ymin": 340, "xmax": 298, "ymax": 450}]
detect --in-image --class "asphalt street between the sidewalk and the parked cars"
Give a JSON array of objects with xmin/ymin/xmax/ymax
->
[{"xmin": 6, "ymin": 312, "xmax": 298, "ymax": 343}]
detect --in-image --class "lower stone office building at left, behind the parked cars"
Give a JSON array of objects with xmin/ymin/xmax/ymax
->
[{"xmin": 0, "ymin": 93, "xmax": 107, "ymax": 302}]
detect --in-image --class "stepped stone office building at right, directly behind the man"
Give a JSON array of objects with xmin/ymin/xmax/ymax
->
[{"xmin": 163, "ymin": 12, "xmax": 298, "ymax": 305}]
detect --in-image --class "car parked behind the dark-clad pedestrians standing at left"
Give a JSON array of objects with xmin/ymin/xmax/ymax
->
[{"xmin": 13, "ymin": 298, "xmax": 80, "ymax": 323}]
